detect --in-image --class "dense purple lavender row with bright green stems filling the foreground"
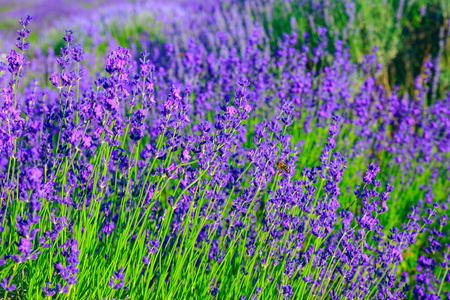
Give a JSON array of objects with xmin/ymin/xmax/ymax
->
[{"xmin": 0, "ymin": 2, "xmax": 450, "ymax": 299}]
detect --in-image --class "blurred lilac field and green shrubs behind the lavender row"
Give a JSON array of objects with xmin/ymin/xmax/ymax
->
[{"xmin": 0, "ymin": 0, "xmax": 450, "ymax": 101}]
